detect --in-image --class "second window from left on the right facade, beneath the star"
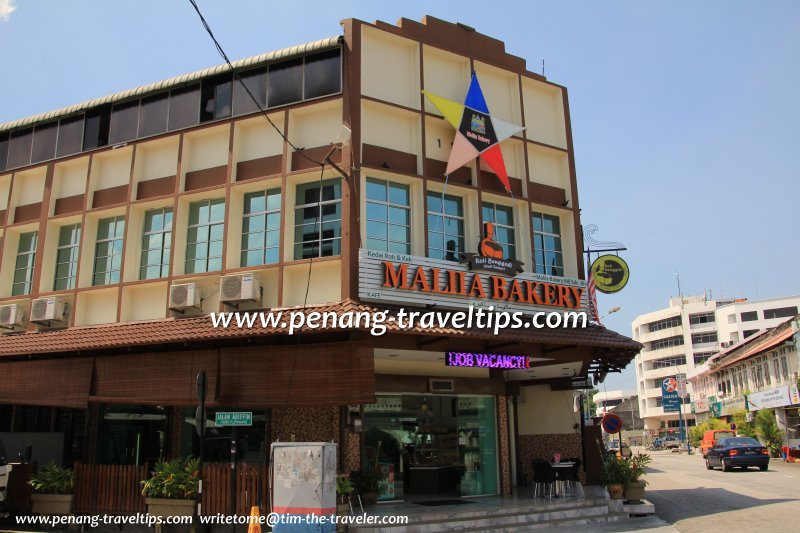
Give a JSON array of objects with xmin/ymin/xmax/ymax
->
[{"xmin": 428, "ymin": 192, "xmax": 464, "ymax": 261}]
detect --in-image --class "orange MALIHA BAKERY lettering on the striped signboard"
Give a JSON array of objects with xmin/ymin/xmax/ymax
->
[{"xmin": 381, "ymin": 261, "xmax": 584, "ymax": 309}]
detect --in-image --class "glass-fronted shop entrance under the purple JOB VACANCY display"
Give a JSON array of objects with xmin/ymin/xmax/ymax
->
[{"xmin": 362, "ymin": 394, "xmax": 498, "ymax": 500}]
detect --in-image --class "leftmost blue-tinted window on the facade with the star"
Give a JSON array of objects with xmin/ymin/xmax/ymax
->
[{"xmin": 367, "ymin": 178, "xmax": 411, "ymax": 254}]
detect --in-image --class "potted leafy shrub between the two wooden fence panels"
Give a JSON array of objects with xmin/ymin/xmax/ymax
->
[{"xmin": 142, "ymin": 457, "xmax": 200, "ymax": 517}]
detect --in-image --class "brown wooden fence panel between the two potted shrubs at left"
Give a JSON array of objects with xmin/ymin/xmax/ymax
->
[{"xmin": 73, "ymin": 464, "xmax": 150, "ymax": 514}]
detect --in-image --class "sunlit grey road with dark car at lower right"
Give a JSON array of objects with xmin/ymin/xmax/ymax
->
[{"xmin": 634, "ymin": 449, "xmax": 800, "ymax": 533}]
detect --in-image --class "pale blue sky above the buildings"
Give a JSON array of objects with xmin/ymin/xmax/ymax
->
[{"xmin": 0, "ymin": 0, "xmax": 800, "ymax": 390}]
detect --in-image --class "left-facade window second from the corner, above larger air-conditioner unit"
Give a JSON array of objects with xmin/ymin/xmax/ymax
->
[{"xmin": 241, "ymin": 189, "xmax": 281, "ymax": 266}]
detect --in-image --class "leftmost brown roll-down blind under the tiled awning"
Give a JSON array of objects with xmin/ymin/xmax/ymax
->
[{"xmin": 0, "ymin": 357, "xmax": 94, "ymax": 409}]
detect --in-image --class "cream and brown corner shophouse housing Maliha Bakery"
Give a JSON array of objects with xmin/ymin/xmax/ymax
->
[{"xmin": 0, "ymin": 17, "xmax": 639, "ymax": 511}]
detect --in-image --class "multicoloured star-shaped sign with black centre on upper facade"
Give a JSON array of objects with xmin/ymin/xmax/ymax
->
[{"xmin": 422, "ymin": 72, "xmax": 525, "ymax": 192}]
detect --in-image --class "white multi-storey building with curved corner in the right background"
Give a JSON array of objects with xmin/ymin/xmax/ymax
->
[{"xmin": 632, "ymin": 296, "xmax": 800, "ymax": 435}]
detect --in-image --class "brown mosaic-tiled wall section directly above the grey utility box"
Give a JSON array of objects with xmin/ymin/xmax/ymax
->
[{"xmin": 272, "ymin": 407, "xmax": 339, "ymax": 442}]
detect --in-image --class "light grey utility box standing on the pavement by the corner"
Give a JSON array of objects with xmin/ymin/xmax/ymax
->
[{"xmin": 271, "ymin": 442, "xmax": 336, "ymax": 533}]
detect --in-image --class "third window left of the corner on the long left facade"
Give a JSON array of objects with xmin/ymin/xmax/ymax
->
[{"xmin": 186, "ymin": 198, "xmax": 225, "ymax": 274}]
